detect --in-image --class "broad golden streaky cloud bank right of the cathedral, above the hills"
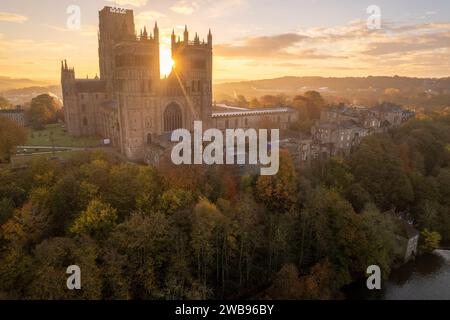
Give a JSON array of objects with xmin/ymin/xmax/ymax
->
[{"xmin": 214, "ymin": 20, "xmax": 450, "ymax": 76}]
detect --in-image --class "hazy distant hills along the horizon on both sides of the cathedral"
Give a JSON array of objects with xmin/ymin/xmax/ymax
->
[{"xmin": 0, "ymin": 76, "xmax": 450, "ymax": 107}]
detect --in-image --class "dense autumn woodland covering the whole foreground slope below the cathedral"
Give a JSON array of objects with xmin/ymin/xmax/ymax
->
[{"xmin": 0, "ymin": 116, "xmax": 450, "ymax": 299}]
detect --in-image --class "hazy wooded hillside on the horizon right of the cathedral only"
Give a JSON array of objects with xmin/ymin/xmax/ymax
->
[{"xmin": 214, "ymin": 76, "xmax": 450, "ymax": 105}]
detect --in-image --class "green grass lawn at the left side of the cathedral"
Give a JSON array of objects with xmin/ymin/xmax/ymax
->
[{"xmin": 26, "ymin": 124, "xmax": 100, "ymax": 148}]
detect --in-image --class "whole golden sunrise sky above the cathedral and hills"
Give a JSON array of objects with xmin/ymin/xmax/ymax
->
[{"xmin": 0, "ymin": 0, "xmax": 450, "ymax": 83}]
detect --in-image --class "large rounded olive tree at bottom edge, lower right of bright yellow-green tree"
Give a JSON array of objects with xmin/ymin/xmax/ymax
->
[{"xmin": 103, "ymin": 212, "xmax": 173, "ymax": 299}]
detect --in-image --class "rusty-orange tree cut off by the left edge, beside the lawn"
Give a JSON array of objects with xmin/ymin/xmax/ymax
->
[{"xmin": 0, "ymin": 117, "xmax": 26, "ymax": 161}]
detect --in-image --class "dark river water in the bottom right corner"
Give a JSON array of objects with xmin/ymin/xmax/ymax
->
[{"xmin": 345, "ymin": 250, "xmax": 450, "ymax": 300}]
